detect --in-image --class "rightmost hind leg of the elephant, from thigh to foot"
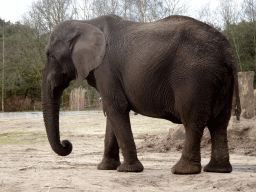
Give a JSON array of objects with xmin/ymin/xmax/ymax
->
[{"xmin": 204, "ymin": 111, "xmax": 232, "ymax": 173}]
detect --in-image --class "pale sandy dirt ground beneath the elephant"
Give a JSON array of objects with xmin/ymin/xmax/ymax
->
[{"xmin": 0, "ymin": 113, "xmax": 256, "ymax": 192}]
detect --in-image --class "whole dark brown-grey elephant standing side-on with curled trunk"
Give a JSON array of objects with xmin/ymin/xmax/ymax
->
[{"xmin": 42, "ymin": 15, "xmax": 241, "ymax": 174}]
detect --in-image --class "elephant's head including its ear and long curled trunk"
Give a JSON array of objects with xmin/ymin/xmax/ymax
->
[{"xmin": 42, "ymin": 21, "xmax": 106, "ymax": 156}]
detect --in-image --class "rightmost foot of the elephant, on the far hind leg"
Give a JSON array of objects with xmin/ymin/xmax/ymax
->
[{"xmin": 204, "ymin": 161, "xmax": 232, "ymax": 173}]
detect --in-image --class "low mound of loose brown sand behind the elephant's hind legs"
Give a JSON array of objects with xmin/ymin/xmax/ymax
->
[{"xmin": 136, "ymin": 117, "xmax": 256, "ymax": 156}]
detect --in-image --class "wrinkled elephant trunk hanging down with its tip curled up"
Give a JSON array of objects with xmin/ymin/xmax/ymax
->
[{"xmin": 42, "ymin": 73, "xmax": 72, "ymax": 156}]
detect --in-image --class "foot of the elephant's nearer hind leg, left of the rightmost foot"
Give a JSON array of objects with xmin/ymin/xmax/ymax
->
[{"xmin": 172, "ymin": 158, "xmax": 202, "ymax": 174}]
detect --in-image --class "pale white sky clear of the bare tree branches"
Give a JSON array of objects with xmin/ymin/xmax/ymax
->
[{"xmin": 0, "ymin": 0, "xmax": 238, "ymax": 23}]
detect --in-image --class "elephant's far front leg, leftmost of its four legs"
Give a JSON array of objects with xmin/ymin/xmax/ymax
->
[{"xmin": 98, "ymin": 118, "xmax": 121, "ymax": 170}]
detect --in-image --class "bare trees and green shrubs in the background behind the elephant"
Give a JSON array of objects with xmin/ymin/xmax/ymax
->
[{"xmin": 0, "ymin": 0, "xmax": 256, "ymax": 111}]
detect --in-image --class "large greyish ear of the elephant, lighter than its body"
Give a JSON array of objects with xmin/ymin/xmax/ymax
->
[{"xmin": 70, "ymin": 22, "xmax": 106, "ymax": 81}]
